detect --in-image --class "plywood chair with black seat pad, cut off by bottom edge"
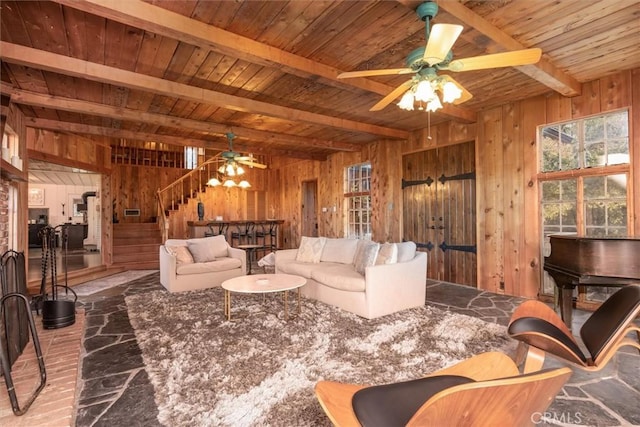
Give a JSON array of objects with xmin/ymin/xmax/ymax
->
[{"xmin": 316, "ymin": 352, "xmax": 571, "ymax": 427}]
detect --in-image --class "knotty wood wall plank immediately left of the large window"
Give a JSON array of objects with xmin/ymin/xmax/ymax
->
[{"xmin": 514, "ymin": 96, "xmax": 546, "ymax": 298}]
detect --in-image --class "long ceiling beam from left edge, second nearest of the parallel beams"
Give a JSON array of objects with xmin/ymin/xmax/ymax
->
[{"xmin": 0, "ymin": 41, "xmax": 409, "ymax": 139}]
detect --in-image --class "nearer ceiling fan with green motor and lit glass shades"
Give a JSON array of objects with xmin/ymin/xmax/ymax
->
[{"xmin": 338, "ymin": 1, "xmax": 542, "ymax": 111}]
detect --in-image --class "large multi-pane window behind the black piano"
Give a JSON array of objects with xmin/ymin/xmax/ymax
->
[{"xmin": 538, "ymin": 110, "xmax": 631, "ymax": 301}]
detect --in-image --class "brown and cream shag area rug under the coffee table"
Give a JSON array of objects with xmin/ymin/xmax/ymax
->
[{"xmin": 126, "ymin": 288, "xmax": 513, "ymax": 427}]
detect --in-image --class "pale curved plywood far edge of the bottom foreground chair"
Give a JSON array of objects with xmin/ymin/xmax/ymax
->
[{"xmin": 427, "ymin": 351, "xmax": 519, "ymax": 381}]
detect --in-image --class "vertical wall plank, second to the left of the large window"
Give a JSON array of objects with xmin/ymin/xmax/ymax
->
[{"xmin": 501, "ymin": 103, "xmax": 526, "ymax": 295}]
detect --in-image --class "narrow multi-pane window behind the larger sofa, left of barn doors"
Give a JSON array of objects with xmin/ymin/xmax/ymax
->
[{"xmin": 344, "ymin": 163, "xmax": 371, "ymax": 240}]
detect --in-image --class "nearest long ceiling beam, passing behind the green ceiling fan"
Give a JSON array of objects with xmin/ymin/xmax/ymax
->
[{"xmin": 54, "ymin": 0, "xmax": 476, "ymax": 123}]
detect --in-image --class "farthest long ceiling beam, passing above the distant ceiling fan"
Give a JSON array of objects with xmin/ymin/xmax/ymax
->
[{"xmin": 25, "ymin": 117, "xmax": 326, "ymax": 160}]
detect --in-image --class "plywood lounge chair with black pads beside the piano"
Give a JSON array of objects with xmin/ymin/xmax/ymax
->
[{"xmin": 508, "ymin": 285, "xmax": 640, "ymax": 372}]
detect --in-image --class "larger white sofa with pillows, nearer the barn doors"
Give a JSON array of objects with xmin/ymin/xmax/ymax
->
[{"xmin": 275, "ymin": 237, "xmax": 427, "ymax": 319}]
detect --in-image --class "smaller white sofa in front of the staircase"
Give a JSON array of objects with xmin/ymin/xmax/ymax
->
[{"xmin": 160, "ymin": 236, "xmax": 247, "ymax": 292}]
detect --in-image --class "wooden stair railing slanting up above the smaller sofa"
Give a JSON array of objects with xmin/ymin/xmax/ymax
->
[{"xmin": 156, "ymin": 154, "xmax": 224, "ymax": 242}]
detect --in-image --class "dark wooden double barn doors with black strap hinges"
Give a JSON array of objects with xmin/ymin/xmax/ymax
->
[{"xmin": 402, "ymin": 142, "xmax": 477, "ymax": 286}]
